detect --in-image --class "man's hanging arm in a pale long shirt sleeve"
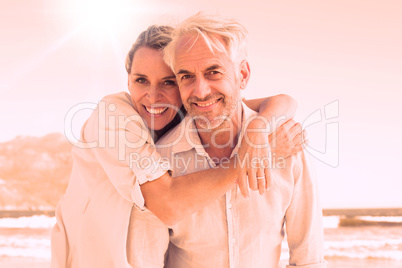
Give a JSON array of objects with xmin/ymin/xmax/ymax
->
[{"xmin": 285, "ymin": 151, "xmax": 327, "ymax": 268}]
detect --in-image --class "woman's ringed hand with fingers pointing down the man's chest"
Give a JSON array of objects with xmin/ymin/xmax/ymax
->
[{"xmin": 236, "ymin": 116, "xmax": 271, "ymax": 197}]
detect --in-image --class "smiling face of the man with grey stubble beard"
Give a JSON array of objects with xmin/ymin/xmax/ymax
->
[{"xmin": 174, "ymin": 36, "xmax": 241, "ymax": 129}]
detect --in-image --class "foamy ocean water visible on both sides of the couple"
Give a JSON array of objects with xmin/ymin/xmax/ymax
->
[{"xmin": 0, "ymin": 215, "xmax": 402, "ymax": 268}]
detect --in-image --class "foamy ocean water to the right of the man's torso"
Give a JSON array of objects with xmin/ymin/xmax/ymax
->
[{"xmin": 281, "ymin": 216, "xmax": 402, "ymax": 268}]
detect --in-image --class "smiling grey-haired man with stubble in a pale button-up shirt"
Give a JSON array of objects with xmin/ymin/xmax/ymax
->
[{"xmin": 158, "ymin": 14, "xmax": 326, "ymax": 268}]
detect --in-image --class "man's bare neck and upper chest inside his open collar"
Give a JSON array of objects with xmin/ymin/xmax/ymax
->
[{"xmin": 198, "ymin": 105, "xmax": 243, "ymax": 162}]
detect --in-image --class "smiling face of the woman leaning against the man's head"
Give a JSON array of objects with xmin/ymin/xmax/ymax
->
[{"xmin": 128, "ymin": 47, "xmax": 182, "ymax": 130}]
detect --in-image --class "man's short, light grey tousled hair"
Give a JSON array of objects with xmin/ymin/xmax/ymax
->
[{"xmin": 164, "ymin": 12, "xmax": 247, "ymax": 70}]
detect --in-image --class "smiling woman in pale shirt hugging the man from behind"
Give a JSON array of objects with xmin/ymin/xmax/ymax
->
[{"xmin": 52, "ymin": 26, "xmax": 301, "ymax": 268}]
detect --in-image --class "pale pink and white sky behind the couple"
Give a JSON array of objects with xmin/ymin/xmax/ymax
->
[{"xmin": 0, "ymin": 0, "xmax": 402, "ymax": 208}]
